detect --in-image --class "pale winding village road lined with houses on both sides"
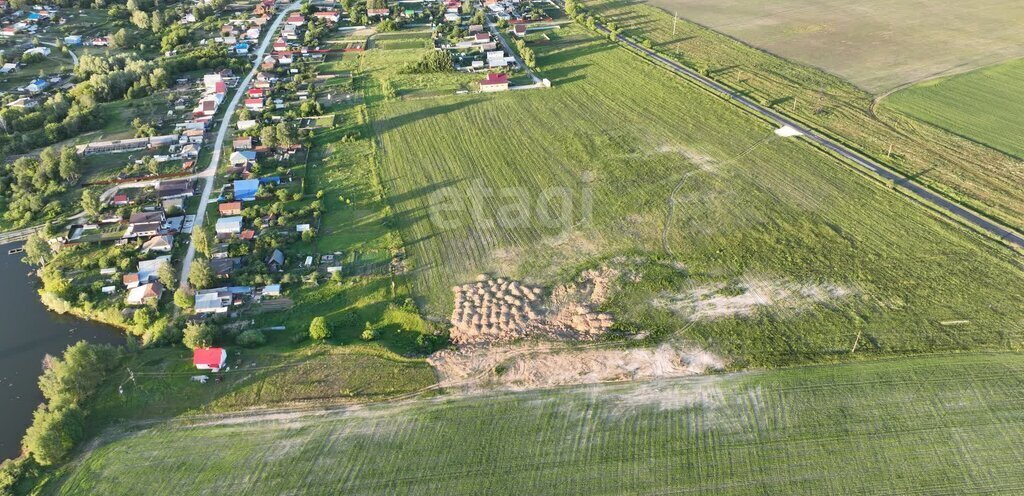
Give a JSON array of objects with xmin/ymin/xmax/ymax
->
[{"xmin": 178, "ymin": 2, "xmax": 301, "ymax": 287}]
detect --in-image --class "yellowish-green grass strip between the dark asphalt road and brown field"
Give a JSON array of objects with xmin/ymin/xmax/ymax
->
[{"xmin": 584, "ymin": 0, "xmax": 1024, "ymax": 229}]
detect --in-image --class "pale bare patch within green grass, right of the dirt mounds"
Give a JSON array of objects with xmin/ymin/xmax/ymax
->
[{"xmin": 653, "ymin": 279, "xmax": 851, "ymax": 321}]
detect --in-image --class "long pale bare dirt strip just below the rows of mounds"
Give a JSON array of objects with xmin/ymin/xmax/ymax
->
[{"xmin": 428, "ymin": 342, "xmax": 726, "ymax": 390}]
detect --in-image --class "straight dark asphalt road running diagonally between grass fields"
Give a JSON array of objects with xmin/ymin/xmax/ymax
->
[{"xmin": 577, "ymin": 18, "xmax": 1024, "ymax": 250}]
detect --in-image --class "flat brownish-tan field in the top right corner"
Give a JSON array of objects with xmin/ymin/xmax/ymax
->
[{"xmin": 647, "ymin": 0, "xmax": 1024, "ymax": 93}]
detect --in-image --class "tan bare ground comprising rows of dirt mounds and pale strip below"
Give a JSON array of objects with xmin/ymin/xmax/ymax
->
[{"xmin": 436, "ymin": 266, "xmax": 725, "ymax": 390}]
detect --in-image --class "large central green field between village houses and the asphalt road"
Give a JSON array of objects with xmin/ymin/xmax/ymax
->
[{"xmin": 362, "ymin": 28, "xmax": 1024, "ymax": 364}]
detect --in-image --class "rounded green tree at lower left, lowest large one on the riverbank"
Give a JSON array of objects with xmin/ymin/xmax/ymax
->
[{"xmin": 22, "ymin": 406, "xmax": 82, "ymax": 466}]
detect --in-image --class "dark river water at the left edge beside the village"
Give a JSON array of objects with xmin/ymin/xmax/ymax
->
[{"xmin": 0, "ymin": 243, "xmax": 125, "ymax": 459}]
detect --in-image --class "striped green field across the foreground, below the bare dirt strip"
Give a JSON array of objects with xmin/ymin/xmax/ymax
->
[{"xmin": 43, "ymin": 354, "xmax": 1024, "ymax": 495}]
